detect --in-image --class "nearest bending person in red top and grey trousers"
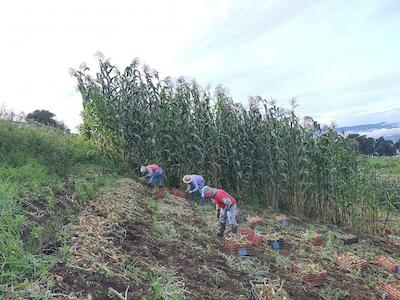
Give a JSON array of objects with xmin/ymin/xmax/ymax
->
[{"xmin": 201, "ymin": 186, "xmax": 237, "ymax": 237}]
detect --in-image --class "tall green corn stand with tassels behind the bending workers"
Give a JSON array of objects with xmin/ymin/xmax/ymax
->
[{"xmin": 74, "ymin": 58, "xmax": 379, "ymax": 227}]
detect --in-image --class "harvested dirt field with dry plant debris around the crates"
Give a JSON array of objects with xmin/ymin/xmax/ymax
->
[{"xmin": 51, "ymin": 180, "xmax": 400, "ymax": 300}]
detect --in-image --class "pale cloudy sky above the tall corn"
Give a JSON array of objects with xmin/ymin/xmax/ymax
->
[{"xmin": 0, "ymin": 0, "xmax": 400, "ymax": 128}]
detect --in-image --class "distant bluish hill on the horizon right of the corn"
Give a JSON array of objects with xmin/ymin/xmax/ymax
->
[{"xmin": 336, "ymin": 122, "xmax": 400, "ymax": 141}]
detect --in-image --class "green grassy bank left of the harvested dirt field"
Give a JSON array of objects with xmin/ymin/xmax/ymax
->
[{"xmin": 0, "ymin": 121, "xmax": 118, "ymax": 297}]
